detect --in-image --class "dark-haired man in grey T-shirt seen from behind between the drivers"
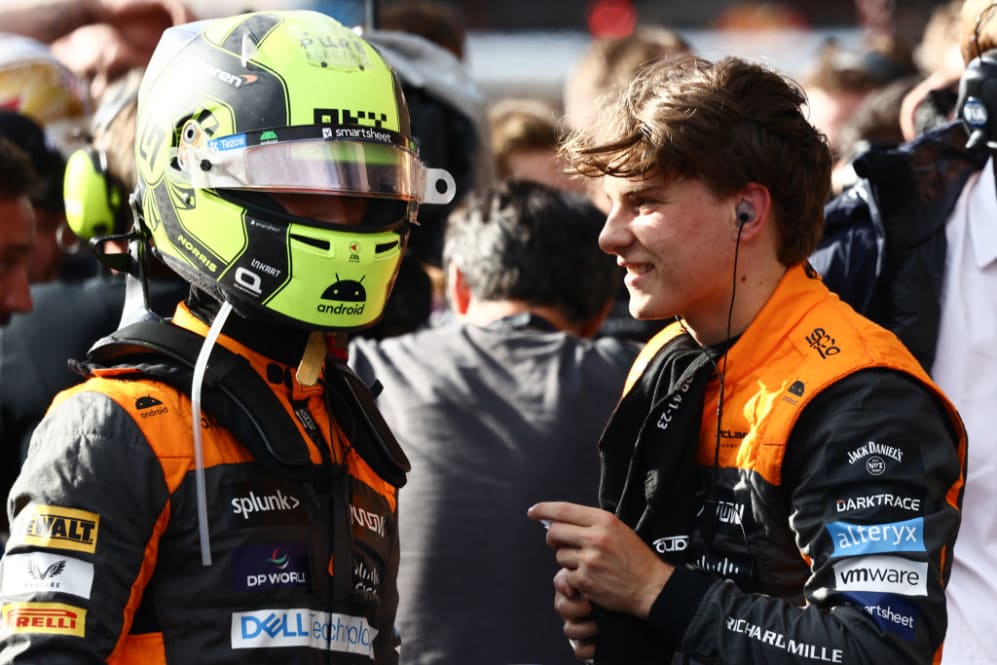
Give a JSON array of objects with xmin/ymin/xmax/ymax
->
[{"xmin": 350, "ymin": 181, "xmax": 637, "ymax": 665}]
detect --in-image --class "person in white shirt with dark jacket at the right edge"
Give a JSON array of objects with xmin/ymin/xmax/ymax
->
[{"xmin": 811, "ymin": 0, "xmax": 997, "ymax": 665}]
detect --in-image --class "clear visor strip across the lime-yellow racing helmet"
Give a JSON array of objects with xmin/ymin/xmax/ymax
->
[{"xmin": 177, "ymin": 135, "xmax": 456, "ymax": 203}]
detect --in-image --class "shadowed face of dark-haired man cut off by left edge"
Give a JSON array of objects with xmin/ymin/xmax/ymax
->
[{"xmin": 0, "ymin": 196, "xmax": 35, "ymax": 326}]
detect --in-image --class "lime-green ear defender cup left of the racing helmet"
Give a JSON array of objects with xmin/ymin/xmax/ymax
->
[{"xmin": 62, "ymin": 147, "xmax": 128, "ymax": 241}]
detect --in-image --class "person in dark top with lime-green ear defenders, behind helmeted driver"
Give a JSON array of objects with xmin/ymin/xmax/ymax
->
[{"xmin": 0, "ymin": 79, "xmax": 188, "ymax": 531}]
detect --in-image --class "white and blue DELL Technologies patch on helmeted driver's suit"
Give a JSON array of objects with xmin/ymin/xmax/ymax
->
[{"xmin": 231, "ymin": 609, "xmax": 377, "ymax": 658}]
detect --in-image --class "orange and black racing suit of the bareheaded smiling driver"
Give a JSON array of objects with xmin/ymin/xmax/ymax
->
[{"xmin": 596, "ymin": 267, "xmax": 966, "ymax": 665}]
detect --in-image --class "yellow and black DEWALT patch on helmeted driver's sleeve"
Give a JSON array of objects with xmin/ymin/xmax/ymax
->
[{"xmin": 8, "ymin": 504, "xmax": 100, "ymax": 554}]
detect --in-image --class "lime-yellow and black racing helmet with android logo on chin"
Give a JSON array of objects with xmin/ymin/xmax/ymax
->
[{"xmin": 135, "ymin": 10, "xmax": 455, "ymax": 330}]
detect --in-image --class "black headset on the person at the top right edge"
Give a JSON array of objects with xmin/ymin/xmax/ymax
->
[{"xmin": 956, "ymin": 3, "xmax": 997, "ymax": 150}]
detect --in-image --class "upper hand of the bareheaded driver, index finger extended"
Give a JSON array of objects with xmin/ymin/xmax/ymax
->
[{"xmin": 527, "ymin": 502, "xmax": 674, "ymax": 619}]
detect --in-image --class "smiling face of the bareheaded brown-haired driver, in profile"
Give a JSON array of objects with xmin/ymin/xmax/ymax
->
[{"xmin": 599, "ymin": 172, "xmax": 737, "ymax": 329}]
